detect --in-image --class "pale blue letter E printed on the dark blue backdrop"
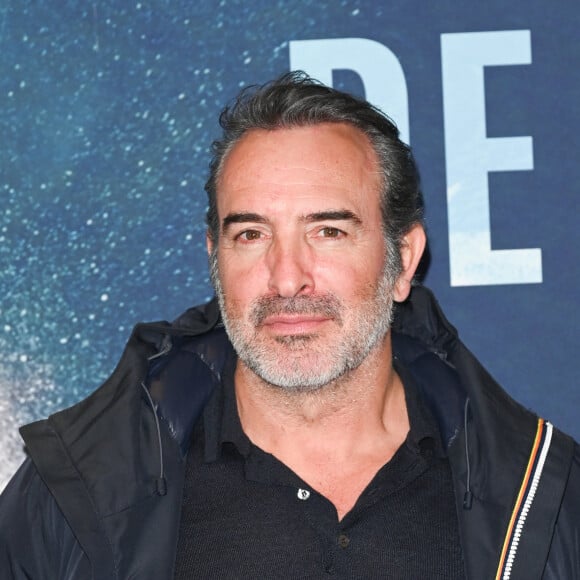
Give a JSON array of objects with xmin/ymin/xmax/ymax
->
[{"xmin": 441, "ymin": 30, "xmax": 542, "ymax": 286}]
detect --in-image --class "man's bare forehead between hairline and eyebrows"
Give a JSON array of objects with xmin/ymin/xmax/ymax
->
[{"xmin": 217, "ymin": 123, "xmax": 382, "ymax": 217}]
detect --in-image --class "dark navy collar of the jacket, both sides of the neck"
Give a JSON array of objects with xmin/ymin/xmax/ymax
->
[{"xmin": 150, "ymin": 286, "xmax": 467, "ymax": 455}]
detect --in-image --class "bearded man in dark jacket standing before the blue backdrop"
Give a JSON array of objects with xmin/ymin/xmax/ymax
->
[{"xmin": 0, "ymin": 73, "xmax": 580, "ymax": 579}]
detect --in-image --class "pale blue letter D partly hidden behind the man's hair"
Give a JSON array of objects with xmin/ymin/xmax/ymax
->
[{"xmin": 290, "ymin": 38, "xmax": 409, "ymax": 143}]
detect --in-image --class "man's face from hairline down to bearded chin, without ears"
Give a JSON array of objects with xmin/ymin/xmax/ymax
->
[{"xmin": 213, "ymin": 124, "xmax": 392, "ymax": 390}]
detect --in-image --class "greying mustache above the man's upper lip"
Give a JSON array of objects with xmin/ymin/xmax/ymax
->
[{"xmin": 250, "ymin": 295, "xmax": 342, "ymax": 326}]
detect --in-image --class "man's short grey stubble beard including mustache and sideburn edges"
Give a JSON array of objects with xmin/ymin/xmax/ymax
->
[{"xmin": 210, "ymin": 252, "xmax": 394, "ymax": 393}]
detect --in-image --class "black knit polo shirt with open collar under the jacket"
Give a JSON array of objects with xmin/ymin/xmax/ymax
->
[{"xmin": 175, "ymin": 360, "xmax": 464, "ymax": 580}]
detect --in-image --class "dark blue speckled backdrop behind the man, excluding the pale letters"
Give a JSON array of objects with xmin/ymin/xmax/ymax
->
[{"xmin": 0, "ymin": 0, "xmax": 580, "ymax": 485}]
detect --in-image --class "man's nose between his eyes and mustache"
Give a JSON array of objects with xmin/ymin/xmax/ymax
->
[{"xmin": 267, "ymin": 240, "xmax": 314, "ymax": 298}]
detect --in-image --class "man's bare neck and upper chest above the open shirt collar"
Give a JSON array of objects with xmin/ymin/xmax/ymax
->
[{"xmin": 235, "ymin": 335, "xmax": 409, "ymax": 520}]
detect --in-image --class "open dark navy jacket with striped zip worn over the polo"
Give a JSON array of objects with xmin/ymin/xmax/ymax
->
[{"xmin": 0, "ymin": 287, "xmax": 580, "ymax": 580}]
